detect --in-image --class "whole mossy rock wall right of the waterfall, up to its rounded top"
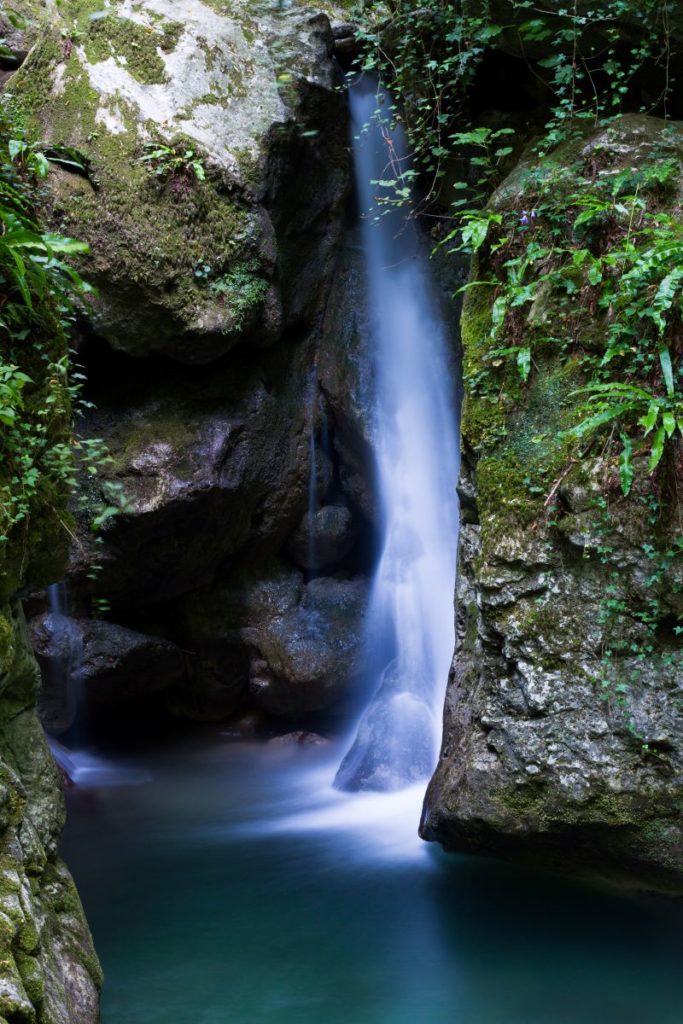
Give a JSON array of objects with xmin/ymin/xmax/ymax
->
[{"xmin": 421, "ymin": 116, "xmax": 683, "ymax": 893}]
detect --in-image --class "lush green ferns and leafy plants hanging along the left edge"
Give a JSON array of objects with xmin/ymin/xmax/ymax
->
[{"xmin": 0, "ymin": 97, "xmax": 118, "ymax": 561}]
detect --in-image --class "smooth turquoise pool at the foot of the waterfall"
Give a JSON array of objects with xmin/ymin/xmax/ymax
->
[{"xmin": 65, "ymin": 737, "xmax": 683, "ymax": 1024}]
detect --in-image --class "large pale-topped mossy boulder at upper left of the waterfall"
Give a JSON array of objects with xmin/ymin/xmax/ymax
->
[{"xmin": 11, "ymin": 0, "xmax": 348, "ymax": 364}]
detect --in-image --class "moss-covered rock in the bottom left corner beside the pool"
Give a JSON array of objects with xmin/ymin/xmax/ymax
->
[{"xmin": 0, "ymin": 603, "xmax": 101, "ymax": 1024}]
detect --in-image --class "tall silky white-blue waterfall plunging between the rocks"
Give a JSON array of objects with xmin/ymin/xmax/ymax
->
[{"xmin": 335, "ymin": 79, "xmax": 459, "ymax": 791}]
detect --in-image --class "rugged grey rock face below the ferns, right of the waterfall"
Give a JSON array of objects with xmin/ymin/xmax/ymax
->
[{"xmin": 421, "ymin": 118, "xmax": 683, "ymax": 893}]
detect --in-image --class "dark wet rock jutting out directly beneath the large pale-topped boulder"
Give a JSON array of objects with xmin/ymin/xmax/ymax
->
[{"xmin": 70, "ymin": 340, "xmax": 312, "ymax": 608}]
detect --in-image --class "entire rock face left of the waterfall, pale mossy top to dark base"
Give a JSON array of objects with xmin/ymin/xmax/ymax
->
[{"xmin": 6, "ymin": 0, "xmax": 373, "ymax": 730}]
